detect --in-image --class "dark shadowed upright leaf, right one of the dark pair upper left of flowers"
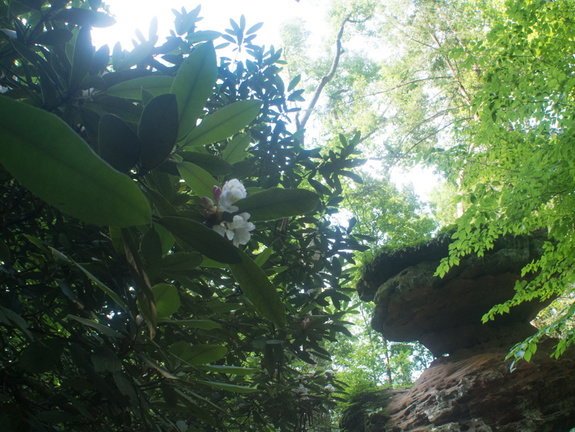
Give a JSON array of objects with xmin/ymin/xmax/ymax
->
[{"xmin": 138, "ymin": 93, "xmax": 178, "ymax": 172}]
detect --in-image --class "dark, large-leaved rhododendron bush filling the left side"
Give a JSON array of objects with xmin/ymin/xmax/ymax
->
[{"xmin": 0, "ymin": 0, "xmax": 365, "ymax": 432}]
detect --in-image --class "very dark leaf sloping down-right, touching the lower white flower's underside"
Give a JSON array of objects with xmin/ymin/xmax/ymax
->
[{"xmin": 158, "ymin": 217, "xmax": 242, "ymax": 264}]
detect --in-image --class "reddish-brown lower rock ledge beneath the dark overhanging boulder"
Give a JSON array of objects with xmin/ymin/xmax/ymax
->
[{"xmin": 341, "ymin": 341, "xmax": 575, "ymax": 432}]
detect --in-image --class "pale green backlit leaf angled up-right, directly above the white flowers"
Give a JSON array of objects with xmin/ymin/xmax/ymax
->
[{"xmin": 185, "ymin": 101, "xmax": 262, "ymax": 146}]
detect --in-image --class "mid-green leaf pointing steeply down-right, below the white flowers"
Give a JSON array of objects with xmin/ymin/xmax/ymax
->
[{"xmin": 230, "ymin": 249, "xmax": 285, "ymax": 325}]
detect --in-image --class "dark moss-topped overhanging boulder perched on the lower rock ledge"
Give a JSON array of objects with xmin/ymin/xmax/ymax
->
[{"xmin": 358, "ymin": 231, "xmax": 545, "ymax": 356}]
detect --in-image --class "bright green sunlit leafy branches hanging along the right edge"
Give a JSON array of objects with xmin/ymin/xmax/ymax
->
[{"xmin": 430, "ymin": 0, "xmax": 575, "ymax": 360}]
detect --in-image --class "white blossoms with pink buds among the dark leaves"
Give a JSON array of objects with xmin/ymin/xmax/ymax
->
[{"xmin": 202, "ymin": 179, "xmax": 256, "ymax": 246}]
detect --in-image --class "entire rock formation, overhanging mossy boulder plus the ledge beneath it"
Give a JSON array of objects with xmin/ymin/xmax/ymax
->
[{"xmin": 341, "ymin": 235, "xmax": 575, "ymax": 432}]
